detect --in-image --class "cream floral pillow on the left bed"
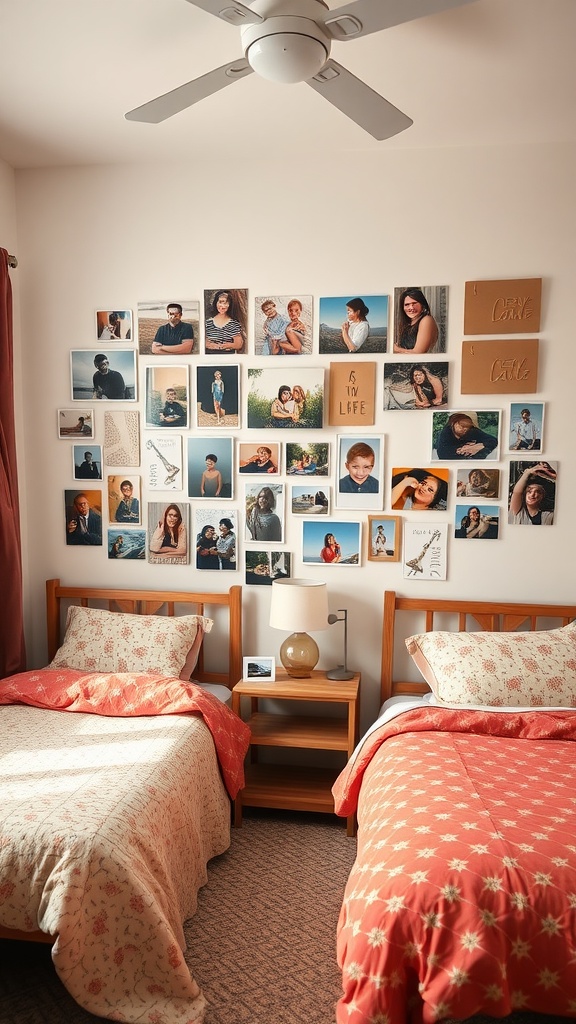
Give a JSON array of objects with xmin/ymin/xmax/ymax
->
[{"xmin": 47, "ymin": 605, "xmax": 212, "ymax": 679}]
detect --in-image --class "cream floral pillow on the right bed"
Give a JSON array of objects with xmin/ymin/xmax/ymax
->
[{"xmin": 406, "ymin": 621, "xmax": 576, "ymax": 708}]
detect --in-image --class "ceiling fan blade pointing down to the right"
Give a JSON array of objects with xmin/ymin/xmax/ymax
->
[{"xmin": 306, "ymin": 60, "xmax": 412, "ymax": 140}]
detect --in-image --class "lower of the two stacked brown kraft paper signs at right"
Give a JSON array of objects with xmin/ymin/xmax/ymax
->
[{"xmin": 460, "ymin": 338, "xmax": 538, "ymax": 394}]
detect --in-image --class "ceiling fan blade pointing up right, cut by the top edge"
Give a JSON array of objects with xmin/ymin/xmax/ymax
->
[{"xmin": 319, "ymin": 0, "xmax": 476, "ymax": 42}]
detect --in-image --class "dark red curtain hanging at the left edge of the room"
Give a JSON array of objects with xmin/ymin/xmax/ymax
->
[{"xmin": 0, "ymin": 249, "xmax": 26, "ymax": 678}]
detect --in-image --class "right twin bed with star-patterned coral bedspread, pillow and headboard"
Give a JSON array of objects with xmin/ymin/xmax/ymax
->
[{"xmin": 334, "ymin": 592, "xmax": 576, "ymax": 1024}]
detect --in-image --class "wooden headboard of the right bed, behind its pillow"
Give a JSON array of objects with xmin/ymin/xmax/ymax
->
[{"xmin": 380, "ymin": 590, "xmax": 576, "ymax": 703}]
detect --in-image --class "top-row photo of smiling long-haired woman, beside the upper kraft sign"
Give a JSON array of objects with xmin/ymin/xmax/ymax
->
[{"xmin": 394, "ymin": 285, "xmax": 448, "ymax": 355}]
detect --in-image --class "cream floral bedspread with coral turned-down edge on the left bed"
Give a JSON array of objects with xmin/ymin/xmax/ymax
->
[{"xmin": 0, "ymin": 672, "xmax": 248, "ymax": 1024}]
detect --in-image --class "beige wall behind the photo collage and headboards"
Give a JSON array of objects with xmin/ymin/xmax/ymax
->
[{"xmin": 12, "ymin": 143, "xmax": 576, "ymax": 721}]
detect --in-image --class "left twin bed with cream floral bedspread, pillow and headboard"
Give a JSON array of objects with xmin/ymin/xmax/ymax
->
[{"xmin": 0, "ymin": 580, "xmax": 249, "ymax": 1024}]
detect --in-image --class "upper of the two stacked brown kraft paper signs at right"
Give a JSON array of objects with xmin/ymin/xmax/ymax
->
[{"xmin": 464, "ymin": 278, "xmax": 542, "ymax": 334}]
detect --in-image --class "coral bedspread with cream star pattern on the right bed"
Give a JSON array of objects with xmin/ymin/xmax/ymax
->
[{"xmin": 334, "ymin": 708, "xmax": 576, "ymax": 1024}]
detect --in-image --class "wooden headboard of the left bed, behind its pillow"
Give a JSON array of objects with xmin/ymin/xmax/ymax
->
[{"xmin": 46, "ymin": 580, "xmax": 242, "ymax": 689}]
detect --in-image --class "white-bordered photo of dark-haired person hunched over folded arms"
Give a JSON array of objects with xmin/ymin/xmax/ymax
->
[{"xmin": 431, "ymin": 409, "xmax": 500, "ymax": 462}]
